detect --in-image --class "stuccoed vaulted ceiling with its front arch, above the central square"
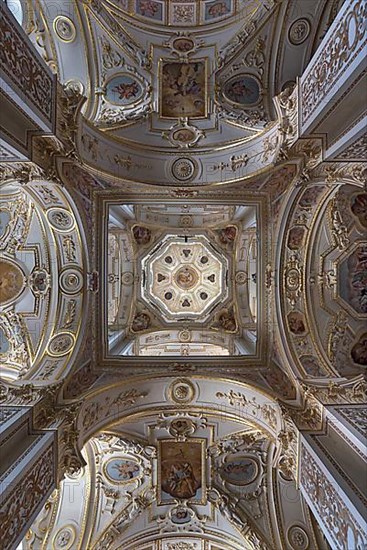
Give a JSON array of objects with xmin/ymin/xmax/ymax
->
[{"xmin": 24, "ymin": 0, "xmax": 342, "ymax": 185}]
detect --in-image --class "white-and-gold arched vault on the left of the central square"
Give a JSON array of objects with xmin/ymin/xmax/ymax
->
[{"xmin": 0, "ymin": 181, "xmax": 87, "ymax": 382}]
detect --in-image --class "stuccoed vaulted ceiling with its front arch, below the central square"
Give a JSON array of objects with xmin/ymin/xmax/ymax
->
[{"xmin": 25, "ymin": 378, "xmax": 317, "ymax": 550}]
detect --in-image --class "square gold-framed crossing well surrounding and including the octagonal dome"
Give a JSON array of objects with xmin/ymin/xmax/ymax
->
[{"xmin": 98, "ymin": 195, "xmax": 264, "ymax": 364}]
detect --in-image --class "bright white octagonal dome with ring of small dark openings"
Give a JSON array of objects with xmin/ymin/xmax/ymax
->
[{"xmin": 142, "ymin": 235, "xmax": 229, "ymax": 321}]
